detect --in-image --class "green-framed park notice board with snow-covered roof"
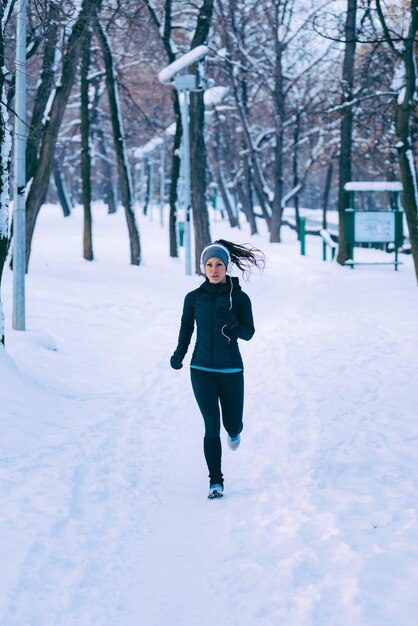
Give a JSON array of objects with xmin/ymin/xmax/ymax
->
[{"xmin": 344, "ymin": 181, "xmax": 403, "ymax": 270}]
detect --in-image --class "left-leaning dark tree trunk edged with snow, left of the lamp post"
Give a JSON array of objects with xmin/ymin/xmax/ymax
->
[{"xmin": 96, "ymin": 20, "xmax": 141, "ymax": 265}]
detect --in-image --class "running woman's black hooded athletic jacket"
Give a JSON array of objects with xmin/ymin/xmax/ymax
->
[{"xmin": 176, "ymin": 276, "xmax": 255, "ymax": 369}]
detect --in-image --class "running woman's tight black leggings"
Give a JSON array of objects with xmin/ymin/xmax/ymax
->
[{"xmin": 190, "ymin": 368, "xmax": 244, "ymax": 485}]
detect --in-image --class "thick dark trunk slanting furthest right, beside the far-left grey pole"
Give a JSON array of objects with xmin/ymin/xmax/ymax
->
[{"xmin": 26, "ymin": 0, "xmax": 101, "ymax": 269}]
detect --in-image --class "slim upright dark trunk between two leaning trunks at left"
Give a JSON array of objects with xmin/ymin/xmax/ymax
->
[{"xmin": 80, "ymin": 30, "xmax": 94, "ymax": 261}]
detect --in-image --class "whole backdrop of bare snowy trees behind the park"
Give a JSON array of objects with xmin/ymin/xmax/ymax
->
[{"xmin": 0, "ymin": 0, "xmax": 418, "ymax": 324}]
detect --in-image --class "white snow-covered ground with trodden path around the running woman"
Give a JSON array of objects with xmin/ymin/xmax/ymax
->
[{"xmin": 0, "ymin": 206, "xmax": 418, "ymax": 626}]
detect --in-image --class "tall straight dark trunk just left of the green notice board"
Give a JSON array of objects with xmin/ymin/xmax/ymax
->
[{"xmin": 337, "ymin": 0, "xmax": 357, "ymax": 265}]
